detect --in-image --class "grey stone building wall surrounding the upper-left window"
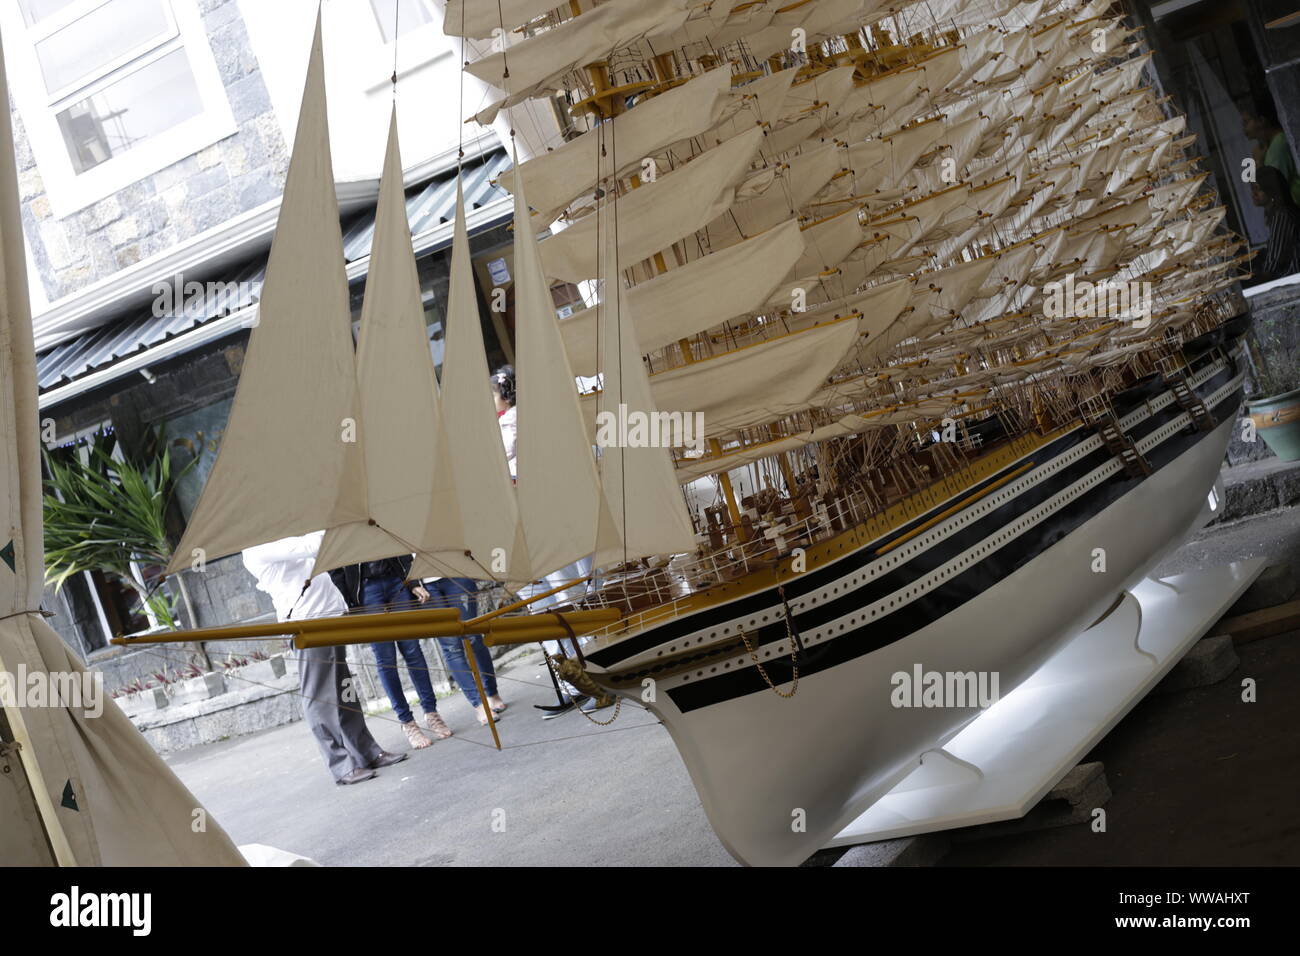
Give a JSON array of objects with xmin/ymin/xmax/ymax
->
[{"xmin": 13, "ymin": 0, "xmax": 289, "ymax": 302}]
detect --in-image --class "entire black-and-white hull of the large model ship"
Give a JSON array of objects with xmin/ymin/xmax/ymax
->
[{"xmin": 586, "ymin": 350, "xmax": 1243, "ymax": 865}]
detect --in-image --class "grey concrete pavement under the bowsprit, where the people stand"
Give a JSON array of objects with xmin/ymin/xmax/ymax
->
[{"xmin": 168, "ymin": 654, "xmax": 735, "ymax": 866}]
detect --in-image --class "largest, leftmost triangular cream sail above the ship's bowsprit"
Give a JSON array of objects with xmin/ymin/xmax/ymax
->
[{"xmin": 168, "ymin": 18, "xmax": 367, "ymax": 572}]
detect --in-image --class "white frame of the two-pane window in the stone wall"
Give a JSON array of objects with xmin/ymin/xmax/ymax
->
[{"xmin": 0, "ymin": 0, "xmax": 239, "ymax": 219}]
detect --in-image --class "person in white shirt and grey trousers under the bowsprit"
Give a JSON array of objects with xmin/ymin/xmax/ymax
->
[{"xmin": 243, "ymin": 531, "xmax": 407, "ymax": 784}]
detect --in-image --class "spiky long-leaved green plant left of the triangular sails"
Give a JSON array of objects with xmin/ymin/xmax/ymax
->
[{"xmin": 44, "ymin": 429, "xmax": 212, "ymax": 670}]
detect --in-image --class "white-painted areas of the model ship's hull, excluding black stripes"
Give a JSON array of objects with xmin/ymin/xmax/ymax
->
[{"xmin": 593, "ymin": 362, "xmax": 1240, "ymax": 865}]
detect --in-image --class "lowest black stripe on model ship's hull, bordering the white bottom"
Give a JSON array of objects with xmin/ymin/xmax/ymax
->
[{"xmin": 668, "ymin": 389, "xmax": 1242, "ymax": 713}]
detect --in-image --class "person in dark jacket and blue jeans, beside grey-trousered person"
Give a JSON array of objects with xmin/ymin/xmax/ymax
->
[{"xmin": 330, "ymin": 555, "xmax": 451, "ymax": 750}]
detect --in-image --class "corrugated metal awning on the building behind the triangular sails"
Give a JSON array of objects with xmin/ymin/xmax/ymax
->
[{"xmin": 36, "ymin": 150, "xmax": 511, "ymax": 401}]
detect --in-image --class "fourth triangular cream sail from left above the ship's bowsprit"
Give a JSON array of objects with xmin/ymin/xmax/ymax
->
[{"xmin": 515, "ymin": 153, "xmax": 610, "ymax": 575}]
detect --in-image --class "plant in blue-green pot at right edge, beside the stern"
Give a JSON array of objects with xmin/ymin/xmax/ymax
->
[{"xmin": 1245, "ymin": 320, "xmax": 1300, "ymax": 462}]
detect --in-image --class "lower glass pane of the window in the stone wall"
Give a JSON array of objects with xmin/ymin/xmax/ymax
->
[{"xmin": 57, "ymin": 49, "xmax": 203, "ymax": 173}]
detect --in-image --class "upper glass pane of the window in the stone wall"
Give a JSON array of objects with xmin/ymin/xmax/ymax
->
[{"xmin": 36, "ymin": 0, "xmax": 172, "ymax": 94}]
